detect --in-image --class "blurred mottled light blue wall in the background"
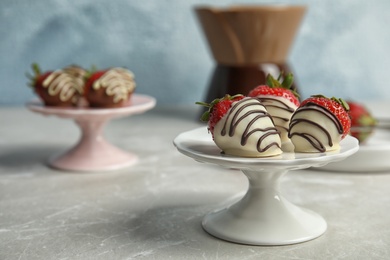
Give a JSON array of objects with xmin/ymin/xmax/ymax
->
[{"xmin": 0, "ymin": 0, "xmax": 390, "ymax": 106}]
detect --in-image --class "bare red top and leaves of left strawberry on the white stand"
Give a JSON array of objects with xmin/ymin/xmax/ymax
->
[{"xmin": 196, "ymin": 94, "xmax": 245, "ymax": 137}]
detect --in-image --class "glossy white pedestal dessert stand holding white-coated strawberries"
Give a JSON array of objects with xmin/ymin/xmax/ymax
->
[{"xmin": 174, "ymin": 127, "xmax": 359, "ymax": 245}]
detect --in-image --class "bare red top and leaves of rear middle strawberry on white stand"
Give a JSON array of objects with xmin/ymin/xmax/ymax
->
[{"xmin": 248, "ymin": 73, "xmax": 299, "ymax": 106}]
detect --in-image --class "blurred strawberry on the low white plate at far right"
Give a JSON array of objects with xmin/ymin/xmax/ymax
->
[{"xmin": 347, "ymin": 101, "xmax": 377, "ymax": 143}]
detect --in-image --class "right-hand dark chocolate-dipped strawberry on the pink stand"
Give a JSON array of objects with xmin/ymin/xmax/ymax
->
[{"xmin": 85, "ymin": 68, "xmax": 136, "ymax": 107}]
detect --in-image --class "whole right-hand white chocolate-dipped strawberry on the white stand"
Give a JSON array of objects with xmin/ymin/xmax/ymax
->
[{"xmin": 289, "ymin": 95, "xmax": 351, "ymax": 152}]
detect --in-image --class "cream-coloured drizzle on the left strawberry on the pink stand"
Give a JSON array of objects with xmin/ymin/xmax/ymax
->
[{"xmin": 42, "ymin": 70, "xmax": 83, "ymax": 104}]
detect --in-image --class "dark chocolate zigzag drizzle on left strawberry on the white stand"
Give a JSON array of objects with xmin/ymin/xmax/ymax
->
[{"xmin": 221, "ymin": 98, "xmax": 281, "ymax": 153}]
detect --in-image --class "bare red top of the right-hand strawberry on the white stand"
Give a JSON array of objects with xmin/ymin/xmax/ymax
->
[{"xmin": 301, "ymin": 95, "xmax": 351, "ymax": 139}]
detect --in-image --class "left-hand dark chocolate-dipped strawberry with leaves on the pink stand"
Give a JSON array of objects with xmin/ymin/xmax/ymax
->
[{"xmin": 27, "ymin": 63, "xmax": 83, "ymax": 107}]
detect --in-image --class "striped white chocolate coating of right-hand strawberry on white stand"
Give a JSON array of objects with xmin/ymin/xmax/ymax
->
[{"xmin": 289, "ymin": 105, "xmax": 342, "ymax": 153}]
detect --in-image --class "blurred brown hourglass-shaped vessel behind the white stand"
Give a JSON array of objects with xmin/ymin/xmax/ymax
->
[{"xmin": 195, "ymin": 5, "xmax": 306, "ymax": 102}]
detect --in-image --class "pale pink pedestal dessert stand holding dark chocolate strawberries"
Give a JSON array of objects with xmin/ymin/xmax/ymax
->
[{"xmin": 27, "ymin": 94, "xmax": 156, "ymax": 171}]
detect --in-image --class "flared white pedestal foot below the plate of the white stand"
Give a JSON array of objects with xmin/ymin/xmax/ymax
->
[{"xmin": 202, "ymin": 171, "xmax": 327, "ymax": 245}]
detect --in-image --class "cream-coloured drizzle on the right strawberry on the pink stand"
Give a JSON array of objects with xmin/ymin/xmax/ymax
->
[{"xmin": 92, "ymin": 68, "xmax": 135, "ymax": 103}]
